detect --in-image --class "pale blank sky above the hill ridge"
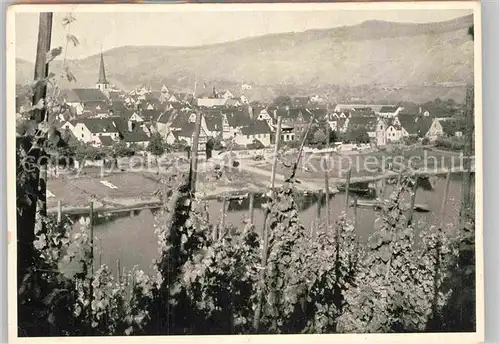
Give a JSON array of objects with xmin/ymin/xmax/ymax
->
[{"xmin": 15, "ymin": 9, "xmax": 472, "ymax": 61}]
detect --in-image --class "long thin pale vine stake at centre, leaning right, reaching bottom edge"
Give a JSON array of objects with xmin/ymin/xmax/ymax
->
[{"xmin": 253, "ymin": 116, "xmax": 281, "ymax": 333}]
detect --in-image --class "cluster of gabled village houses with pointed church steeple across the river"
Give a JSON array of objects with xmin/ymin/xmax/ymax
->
[{"xmin": 16, "ymin": 54, "xmax": 464, "ymax": 158}]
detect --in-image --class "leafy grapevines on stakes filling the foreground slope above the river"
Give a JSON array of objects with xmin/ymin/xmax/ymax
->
[{"xmin": 16, "ymin": 12, "xmax": 476, "ymax": 337}]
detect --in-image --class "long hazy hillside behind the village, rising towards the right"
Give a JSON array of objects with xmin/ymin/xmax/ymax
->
[{"xmin": 16, "ymin": 15, "xmax": 474, "ymax": 99}]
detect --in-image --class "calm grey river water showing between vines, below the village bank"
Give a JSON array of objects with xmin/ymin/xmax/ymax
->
[{"xmin": 88, "ymin": 176, "xmax": 474, "ymax": 272}]
